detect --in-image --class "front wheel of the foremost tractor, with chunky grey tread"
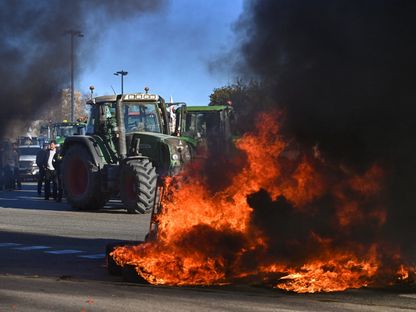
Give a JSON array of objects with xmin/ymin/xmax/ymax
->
[{"xmin": 120, "ymin": 158, "xmax": 157, "ymax": 213}]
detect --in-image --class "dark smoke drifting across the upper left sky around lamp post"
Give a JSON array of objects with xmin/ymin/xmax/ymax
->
[{"xmin": 0, "ymin": 0, "xmax": 163, "ymax": 137}]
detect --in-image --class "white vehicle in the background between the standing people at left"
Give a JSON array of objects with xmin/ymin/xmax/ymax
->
[{"xmin": 18, "ymin": 145, "xmax": 42, "ymax": 181}]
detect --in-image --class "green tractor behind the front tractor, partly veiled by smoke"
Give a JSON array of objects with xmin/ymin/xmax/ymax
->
[{"xmin": 175, "ymin": 105, "xmax": 234, "ymax": 155}]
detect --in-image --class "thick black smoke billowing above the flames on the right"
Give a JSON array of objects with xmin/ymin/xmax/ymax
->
[{"xmin": 234, "ymin": 0, "xmax": 416, "ymax": 256}]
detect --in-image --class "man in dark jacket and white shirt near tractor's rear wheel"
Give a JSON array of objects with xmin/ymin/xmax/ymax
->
[{"xmin": 36, "ymin": 140, "xmax": 63, "ymax": 202}]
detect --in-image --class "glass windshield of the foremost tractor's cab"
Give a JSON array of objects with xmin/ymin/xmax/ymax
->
[{"xmin": 124, "ymin": 102, "xmax": 162, "ymax": 133}]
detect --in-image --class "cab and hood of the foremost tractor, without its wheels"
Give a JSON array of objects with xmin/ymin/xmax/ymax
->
[{"xmin": 87, "ymin": 90, "xmax": 190, "ymax": 173}]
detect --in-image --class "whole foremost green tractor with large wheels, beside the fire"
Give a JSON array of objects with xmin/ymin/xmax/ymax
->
[{"xmin": 61, "ymin": 88, "xmax": 191, "ymax": 213}]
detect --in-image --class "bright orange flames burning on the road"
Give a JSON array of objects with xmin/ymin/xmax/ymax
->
[{"xmin": 112, "ymin": 113, "xmax": 414, "ymax": 292}]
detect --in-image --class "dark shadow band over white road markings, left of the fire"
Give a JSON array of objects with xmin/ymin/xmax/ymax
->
[{"xmin": 0, "ymin": 230, "xmax": 132, "ymax": 281}]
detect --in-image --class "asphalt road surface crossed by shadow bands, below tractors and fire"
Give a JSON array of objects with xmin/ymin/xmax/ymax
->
[{"xmin": 0, "ymin": 184, "xmax": 416, "ymax": 312}]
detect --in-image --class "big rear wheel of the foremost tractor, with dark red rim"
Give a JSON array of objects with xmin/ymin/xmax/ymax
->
[{"xmin": 62, "ymin": 144, "xmax": 106, "ymax": 210}]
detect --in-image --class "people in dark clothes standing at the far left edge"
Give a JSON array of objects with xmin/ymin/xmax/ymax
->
[{"xmin": 0, "ymin": 142, "xmax": 22, "ymax": 191}]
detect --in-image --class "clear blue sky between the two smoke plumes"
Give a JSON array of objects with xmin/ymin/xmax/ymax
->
[{"xmin": 79, "ymin": 0, "xmax": 243, "ymax": 105}]
